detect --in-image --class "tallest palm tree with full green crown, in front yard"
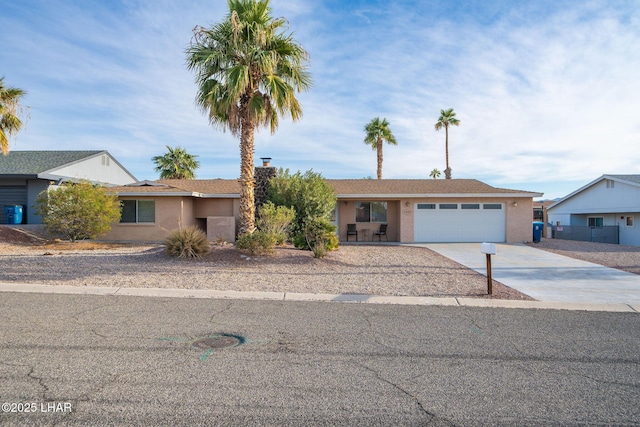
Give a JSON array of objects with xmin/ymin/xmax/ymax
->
[{"xmin": 186, "ymin": 0, "xmax": 312, "ymax": 234}]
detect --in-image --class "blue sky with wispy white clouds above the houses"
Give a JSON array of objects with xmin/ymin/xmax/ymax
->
[{"xmin": 0, "ymin": 0, "xmax": 640, "ymax": 198}]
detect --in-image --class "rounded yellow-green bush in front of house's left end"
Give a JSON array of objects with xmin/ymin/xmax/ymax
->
[{"xmin": 34, "ymin": 182, "xmax": 120, "ymax": 242}]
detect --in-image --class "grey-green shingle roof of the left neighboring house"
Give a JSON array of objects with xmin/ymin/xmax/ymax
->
[{"xmin": 0, "ymin": 150, "xmax": 106, "ymax": 175}]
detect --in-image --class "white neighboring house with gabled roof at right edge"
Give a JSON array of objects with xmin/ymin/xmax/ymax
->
[{"xmin": 547, "ymin": 175, "xmax": 640, "ymax": 246}]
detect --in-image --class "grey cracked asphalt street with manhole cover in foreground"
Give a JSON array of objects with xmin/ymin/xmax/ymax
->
[{"xmin": 0, "ymin": 292, "xmax": 640, "ymax": 426}]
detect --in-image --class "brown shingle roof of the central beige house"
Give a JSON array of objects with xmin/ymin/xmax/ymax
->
[{"xmin": 111, "ymin": 179, "xmax": 542, "ymax": 198}]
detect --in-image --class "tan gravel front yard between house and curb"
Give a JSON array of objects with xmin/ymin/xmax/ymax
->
[{"xmin": 0, "ymin": 227, "xmax": 532, "ymax": 300}]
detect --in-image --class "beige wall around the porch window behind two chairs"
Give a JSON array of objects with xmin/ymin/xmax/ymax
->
[{"xmin": 338, "ymin": 199, "xmax": 400, "ymax": 242}]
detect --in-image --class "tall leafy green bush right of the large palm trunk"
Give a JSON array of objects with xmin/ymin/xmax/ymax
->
[{"xmin": 267, "ymin": 169, "xmax": 336, "ymax": 246}]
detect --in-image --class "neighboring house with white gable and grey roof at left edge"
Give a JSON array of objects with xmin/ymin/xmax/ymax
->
[{"xmin": 0, "ymin": 151, "xmax": 136, "ymax": 224}]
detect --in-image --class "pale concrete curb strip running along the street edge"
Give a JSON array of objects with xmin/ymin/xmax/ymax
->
[{"xmin": 0, "ymin": 282, "xmax": 640, "ymax": 313}]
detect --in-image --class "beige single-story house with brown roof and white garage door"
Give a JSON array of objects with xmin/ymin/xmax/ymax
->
[{"xmin": 104, "ymin": 168, "xmax": 542, "ymax": 242}]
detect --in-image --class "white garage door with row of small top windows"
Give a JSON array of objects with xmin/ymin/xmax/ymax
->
[{"xmin": 414, "ymin": 203, "xmax": 506, "ymax": 243}]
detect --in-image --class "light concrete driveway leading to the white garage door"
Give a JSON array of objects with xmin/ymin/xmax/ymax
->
[{"xmin": 413, "ymin": 243, "xmax": 640, "ymax": 304}]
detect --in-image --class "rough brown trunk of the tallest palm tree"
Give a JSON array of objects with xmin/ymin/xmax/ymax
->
[{"xmin": 238, "ymin": 110, "xmax": 256, "ymax": 235}]
